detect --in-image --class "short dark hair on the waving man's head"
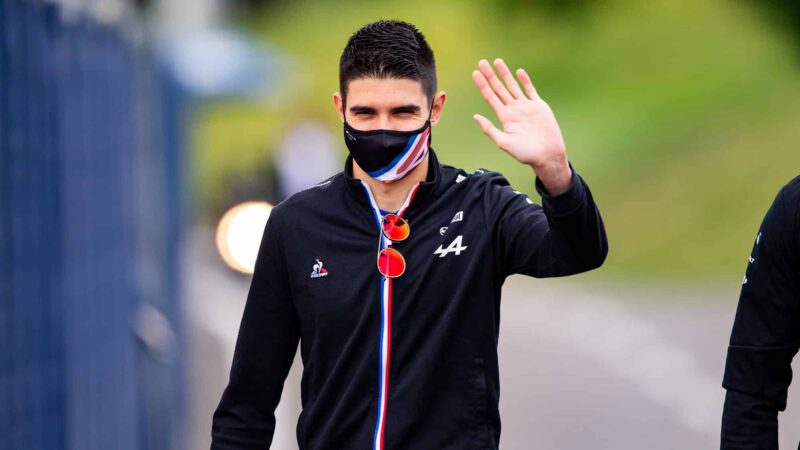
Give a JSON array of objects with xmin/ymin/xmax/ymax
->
[{"xmin": 339, "ymin": 20, "xmax": 436, "ymax": 105}]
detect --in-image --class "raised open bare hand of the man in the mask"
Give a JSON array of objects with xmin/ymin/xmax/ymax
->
[{"xmin": 472, "ymin": 58, "xmax": 572, "ymax": 195}]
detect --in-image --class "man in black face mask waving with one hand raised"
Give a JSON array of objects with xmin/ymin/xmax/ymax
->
[{"xmin": 212, "ymin": 21, "xmax": 607, "ymax": 450}]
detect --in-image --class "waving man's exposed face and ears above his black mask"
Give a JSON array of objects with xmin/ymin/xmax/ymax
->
[{"xmin": 333, "ymin": 78, "xmax": 445, "ymax": 131}]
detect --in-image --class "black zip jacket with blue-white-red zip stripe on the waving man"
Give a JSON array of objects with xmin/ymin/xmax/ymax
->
[{"xmin": 211, "ymin": 150, "xmax": 608, "ymax": 450}]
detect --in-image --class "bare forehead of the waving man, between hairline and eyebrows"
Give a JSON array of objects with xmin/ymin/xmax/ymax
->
[{"xmin": 347, "ymin": 77, "xmax": 426, "ymax": 108}]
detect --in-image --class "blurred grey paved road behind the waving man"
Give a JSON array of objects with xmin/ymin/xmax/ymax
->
[{"xmin": 184, "ymin": 229, "xmax": 800, "ymax": 450}]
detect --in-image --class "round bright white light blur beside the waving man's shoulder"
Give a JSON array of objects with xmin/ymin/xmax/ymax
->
[{"xmin": 217, "ymin": 202, "xmax": 272, "ymax": 275}]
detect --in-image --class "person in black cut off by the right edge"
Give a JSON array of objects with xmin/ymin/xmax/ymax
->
[{"xmin": 722, "ymin": 177, "xmax": 800, "ymax": 450}]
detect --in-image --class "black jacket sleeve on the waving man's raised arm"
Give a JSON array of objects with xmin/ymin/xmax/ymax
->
[{"xmin": 485, "ymin": 165, "xmax": 608, "ymax": 278}]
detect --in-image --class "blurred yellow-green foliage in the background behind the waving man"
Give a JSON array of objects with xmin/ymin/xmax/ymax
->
[{"xmin": 194, "ymin": 0, "xmax": 800, "ymax": 281}]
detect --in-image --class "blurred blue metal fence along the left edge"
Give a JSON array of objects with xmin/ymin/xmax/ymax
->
[{"xmin": 0, "ymin": 0, "xmax": 184, "ymax": 450}]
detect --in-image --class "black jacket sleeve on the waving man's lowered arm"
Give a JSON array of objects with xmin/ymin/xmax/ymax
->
[{"xmin": 211, "ymin": 207, "xmax": 300, "ymax": 450}]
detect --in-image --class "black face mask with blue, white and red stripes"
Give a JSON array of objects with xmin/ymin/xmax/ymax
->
[{"xmin": 344, "ymin": 105, "xmax": 433, "ymax": 183}]
